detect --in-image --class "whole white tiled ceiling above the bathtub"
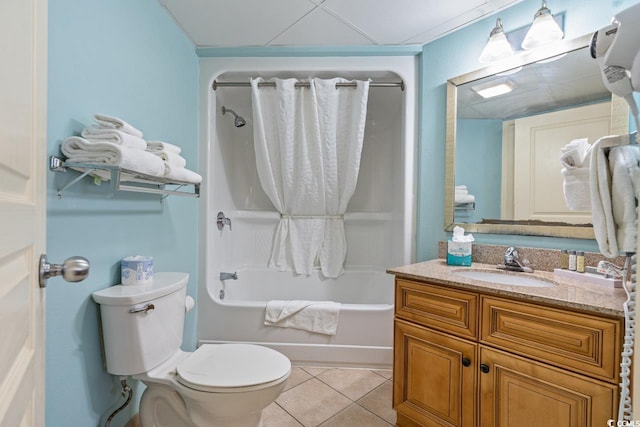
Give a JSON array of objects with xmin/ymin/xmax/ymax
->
[{"xmin": 158, "ymin": 0, "xmax": 521, "ymax": 47}]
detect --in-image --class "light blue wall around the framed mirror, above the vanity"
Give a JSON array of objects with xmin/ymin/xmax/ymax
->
[{"xmin": 416, "ymin": 0, "xmax": 638, "ymax": 261}]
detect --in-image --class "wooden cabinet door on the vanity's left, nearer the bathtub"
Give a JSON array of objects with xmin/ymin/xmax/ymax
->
[{"xmin": 393, "ymin": 320, "xmax": 477, "ymax": 427}]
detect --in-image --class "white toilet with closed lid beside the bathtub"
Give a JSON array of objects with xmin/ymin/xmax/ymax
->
[{"xmin": 93, "ymin": 273, "xmax": 291, "ymax": 427}]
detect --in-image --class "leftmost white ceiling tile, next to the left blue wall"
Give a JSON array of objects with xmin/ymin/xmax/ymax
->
[{"xmin": 161, "ymin": 0, "xmax": 317, "ymax": 46}]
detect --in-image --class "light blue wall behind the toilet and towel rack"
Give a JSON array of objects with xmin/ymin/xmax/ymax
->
[{"xmin": 46, "ymin": 0, "xmax": 199, "ymax": 427}]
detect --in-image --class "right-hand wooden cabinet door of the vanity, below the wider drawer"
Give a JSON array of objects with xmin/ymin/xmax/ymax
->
[{"xmin": 478, "ymin": 346, "xmax": 618, "ymax": 427}]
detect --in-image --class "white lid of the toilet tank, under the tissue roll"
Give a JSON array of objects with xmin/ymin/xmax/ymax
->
[{"xmin": 92, "ymin": 273, "xmax": 189, "ymax": 305}]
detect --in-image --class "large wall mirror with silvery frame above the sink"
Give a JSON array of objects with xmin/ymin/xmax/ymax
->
[{"xmin": 445, "ymin": 34, "xmax": 628, "ymax": 239}]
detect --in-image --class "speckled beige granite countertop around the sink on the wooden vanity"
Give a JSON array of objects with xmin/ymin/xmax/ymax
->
[{"xmin": 387, "ymin": 259, "xmax": 627, "ymax": 317}]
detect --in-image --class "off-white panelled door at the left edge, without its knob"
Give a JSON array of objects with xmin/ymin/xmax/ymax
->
[{"xmin": 0, "ymin": 0, "xmax": 47, "ymax": 427}]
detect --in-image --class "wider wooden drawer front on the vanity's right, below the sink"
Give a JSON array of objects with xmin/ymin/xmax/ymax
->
[{"xmin": 480, "ymin": 296, "xmax": 623, "ymax": 382}]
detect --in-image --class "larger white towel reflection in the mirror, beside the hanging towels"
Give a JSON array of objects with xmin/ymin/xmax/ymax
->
[{"xmin": 560, "ymin": 138, "xmax": 591, "ymax": 211}]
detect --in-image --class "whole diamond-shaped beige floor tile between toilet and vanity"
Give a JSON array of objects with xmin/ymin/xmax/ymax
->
[{"xmin": 276, "ymin": 378, "xmax": 351, "ymax": 427}]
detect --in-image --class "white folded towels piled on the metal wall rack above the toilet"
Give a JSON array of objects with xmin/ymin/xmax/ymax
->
[{"xmin": 60, "ymin": 114, "xmax": 202, "ymax": 184}]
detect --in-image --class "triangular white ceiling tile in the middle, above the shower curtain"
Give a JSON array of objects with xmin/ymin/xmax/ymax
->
[{"xmin": 270, "ymin": 8, "xmax": 376, "ymax": 46}]
